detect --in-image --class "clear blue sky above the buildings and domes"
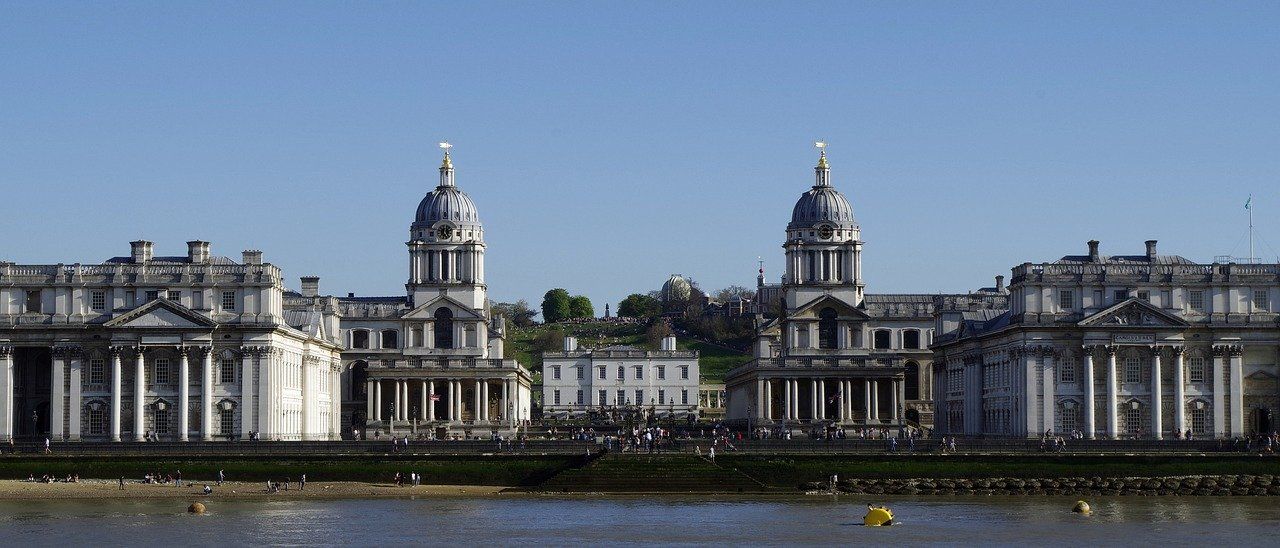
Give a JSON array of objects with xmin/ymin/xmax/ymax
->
[{"xmin": 0, "ymin": 1, "xmax": 1280, "ymax": 311}]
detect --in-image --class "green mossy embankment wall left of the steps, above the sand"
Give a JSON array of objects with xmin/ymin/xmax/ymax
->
[{"xmin": 0, "ymin": 456, "xmax": 581, "ymax": 485}]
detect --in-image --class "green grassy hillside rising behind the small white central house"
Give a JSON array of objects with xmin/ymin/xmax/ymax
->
[{"xmin": 507, "ymin": 321, "xmax": 751, "ymax": 383}]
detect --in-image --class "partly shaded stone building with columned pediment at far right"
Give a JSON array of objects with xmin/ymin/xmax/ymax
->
[{"xmin": 933, "ymin": 241, "xmax": 1280, "ymax": 439}]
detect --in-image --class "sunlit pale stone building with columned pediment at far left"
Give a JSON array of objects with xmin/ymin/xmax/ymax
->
[{"xmin": 0, "ymin": 241, "xmax": 340, "ymax": 440}]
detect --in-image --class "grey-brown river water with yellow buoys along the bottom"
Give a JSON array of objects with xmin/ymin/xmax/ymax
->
[{"xmin": 0, "ymin": 496, "xmax": 1280, "ymax": 548}]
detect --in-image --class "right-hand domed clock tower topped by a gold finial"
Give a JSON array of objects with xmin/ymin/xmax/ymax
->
[{"xmin": 782, "ymin": 149, "xmax": 864, "ymax": 309}]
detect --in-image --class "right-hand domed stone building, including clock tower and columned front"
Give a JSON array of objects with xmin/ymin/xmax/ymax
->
[{"xmin": 724, "ymin": 152, "xmax": 1005, "ymax": 426}]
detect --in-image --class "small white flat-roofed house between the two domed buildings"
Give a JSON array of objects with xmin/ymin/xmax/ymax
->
[{"xmin": 543, "ymin": 337, "xmax": 699, "ymax": 417}]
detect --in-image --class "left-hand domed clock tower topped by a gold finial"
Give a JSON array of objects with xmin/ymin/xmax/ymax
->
[{"xmin": 404, "ymin": 147, "xmax": 485, "ymax": 310}]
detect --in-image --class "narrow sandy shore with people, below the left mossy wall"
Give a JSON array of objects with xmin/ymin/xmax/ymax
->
[{"xmin": 0, "ymin": 479, "xmax": 503, "ymax": 501}]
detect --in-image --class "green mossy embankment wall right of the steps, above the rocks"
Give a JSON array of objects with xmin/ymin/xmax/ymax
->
[{"xmin": 717, "ymin": 453, "xmax": 1280, "ymax": 487}]
